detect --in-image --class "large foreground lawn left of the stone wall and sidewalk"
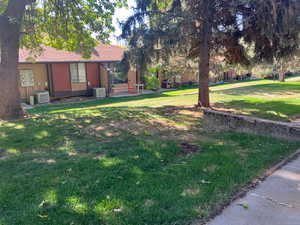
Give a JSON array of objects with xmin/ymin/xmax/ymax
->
[{"xmin": 0, "ymin": 81, "xmax": 300, "ymax": 225}]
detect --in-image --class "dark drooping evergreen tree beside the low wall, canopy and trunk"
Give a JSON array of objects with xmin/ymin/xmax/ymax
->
[{"xmin": 122, "ymin": 0, "xmax": 300, "ymax": 106}]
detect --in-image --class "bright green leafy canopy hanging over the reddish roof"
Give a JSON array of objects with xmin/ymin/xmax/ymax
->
[{"xmin": 0, "ymin": 0, "xmax": 126, "ymax": 57}]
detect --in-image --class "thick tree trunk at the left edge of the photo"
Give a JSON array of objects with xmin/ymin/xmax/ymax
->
[{"xmin": 0, "ymin": 0, "xmax": 30, "ymax": 119}]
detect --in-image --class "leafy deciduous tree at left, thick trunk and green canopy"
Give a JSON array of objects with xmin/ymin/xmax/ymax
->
[{"xmin": 0, "ymin": 0, "xmax": 122, "ymax": 119}]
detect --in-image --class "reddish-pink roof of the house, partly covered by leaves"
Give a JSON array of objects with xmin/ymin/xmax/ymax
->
[{"xmin": 19, "ymin": 44, "xmax": 124, "ymax": 63}]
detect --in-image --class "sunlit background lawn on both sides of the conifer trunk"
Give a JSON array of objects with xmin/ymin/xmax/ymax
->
[{"xmin": 32, "ymin": 78, "xmax": 300, "ymax": 121}]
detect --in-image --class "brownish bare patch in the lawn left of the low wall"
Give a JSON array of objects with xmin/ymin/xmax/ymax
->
[{"xmin": 81, "ymin": 112, "xmax": 210, "ymax": 143}]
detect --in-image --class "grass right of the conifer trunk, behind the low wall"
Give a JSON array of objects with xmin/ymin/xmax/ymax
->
[{"xmin": 212, "ymin": 81, "xmax": 300, "ymax": 121}]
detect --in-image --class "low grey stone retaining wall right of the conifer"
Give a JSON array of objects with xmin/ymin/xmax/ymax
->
[{"xmin": 204, "ymin": 110, "xmax": 300, "ymax": 141}]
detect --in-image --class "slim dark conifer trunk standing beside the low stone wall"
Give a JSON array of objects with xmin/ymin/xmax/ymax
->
[{"xmin": 198, "ymin": 6, "xmax": 212, "ymax": 107}]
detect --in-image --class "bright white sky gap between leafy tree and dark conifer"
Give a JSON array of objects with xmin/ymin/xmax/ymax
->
[{"xmin": 110, "ymin": 0, "xmax": 135, "ymax": 44}]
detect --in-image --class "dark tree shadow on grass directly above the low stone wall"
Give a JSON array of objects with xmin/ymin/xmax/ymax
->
[{"xmin": 215, "ymin": 100, "xmax": 300, "ymax": 122}]
